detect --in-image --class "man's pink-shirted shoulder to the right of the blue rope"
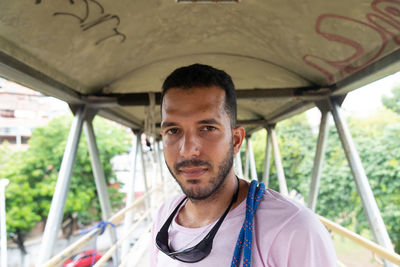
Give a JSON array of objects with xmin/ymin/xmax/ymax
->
[{"xmin": 256, "ymin": 190, "xmax": 336, "ymax": 267}]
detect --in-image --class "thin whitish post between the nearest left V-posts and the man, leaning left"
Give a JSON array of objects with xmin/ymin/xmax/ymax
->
[{"xmin": 121, "ymin": 133, "xmax": 140, "ymax": 258}]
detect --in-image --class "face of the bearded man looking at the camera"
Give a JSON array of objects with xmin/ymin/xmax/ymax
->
[{"xmin": 161, "ymin": 87, "xmax": 242, "ymax": 199}]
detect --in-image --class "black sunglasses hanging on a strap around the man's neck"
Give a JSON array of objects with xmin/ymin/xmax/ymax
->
[{"xmin": 156, "ymin": 177, "xmax": 239, "ymax": 263}]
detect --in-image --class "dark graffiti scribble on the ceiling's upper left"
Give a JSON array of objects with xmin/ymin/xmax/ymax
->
[{"xmin": 35, "ymin": 0, "xmax": 126, "ymax": 45}]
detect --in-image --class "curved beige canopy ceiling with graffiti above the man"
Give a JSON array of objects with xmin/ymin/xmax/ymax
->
[{"xmin": 0, "ymin": 0, "xmax": 400, "ymax": 132}]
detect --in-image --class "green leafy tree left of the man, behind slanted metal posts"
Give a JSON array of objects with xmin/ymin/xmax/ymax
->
[{"xmin": 0, "ymin": 116, "xmax": 130, "ymax": 251}]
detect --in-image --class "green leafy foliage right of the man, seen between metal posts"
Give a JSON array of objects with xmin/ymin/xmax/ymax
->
[{"xmin": 248, "ymin": 109, "xmax": 400, "ymax": 252}]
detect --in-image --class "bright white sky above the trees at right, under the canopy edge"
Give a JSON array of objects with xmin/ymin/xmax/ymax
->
[{"xmin": 307, "ymin": 71, "xmax": 400, "ymax": 126}]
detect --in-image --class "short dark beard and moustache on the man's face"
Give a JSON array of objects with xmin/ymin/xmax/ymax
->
[{"xmin": 166, "ymin": 141, "xmax": 233, "ymax": 200}]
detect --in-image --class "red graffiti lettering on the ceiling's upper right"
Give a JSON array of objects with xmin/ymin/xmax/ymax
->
[{"xmin": 303, "ymin": 0, "xmax": 400, "ymax": 83}]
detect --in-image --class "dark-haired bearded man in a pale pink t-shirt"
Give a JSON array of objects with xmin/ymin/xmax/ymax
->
[{"xmin": 151, "ymin": 64, "xmax": 336, "ymax": 267}]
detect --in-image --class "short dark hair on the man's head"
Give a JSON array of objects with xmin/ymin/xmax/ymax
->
[{"xmin": 161, "ymin": 64, "xmax": 237, "ymax": 128}]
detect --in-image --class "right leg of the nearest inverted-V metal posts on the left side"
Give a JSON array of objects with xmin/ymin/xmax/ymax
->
[{"xmin": 83, "ymin": 118, "xmax": 118, "ymax": 264}]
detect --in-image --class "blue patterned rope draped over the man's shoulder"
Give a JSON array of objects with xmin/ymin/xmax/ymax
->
[{"xmin": 231, "ymin": 180, "xmax": 265, "ymax": 267}]
